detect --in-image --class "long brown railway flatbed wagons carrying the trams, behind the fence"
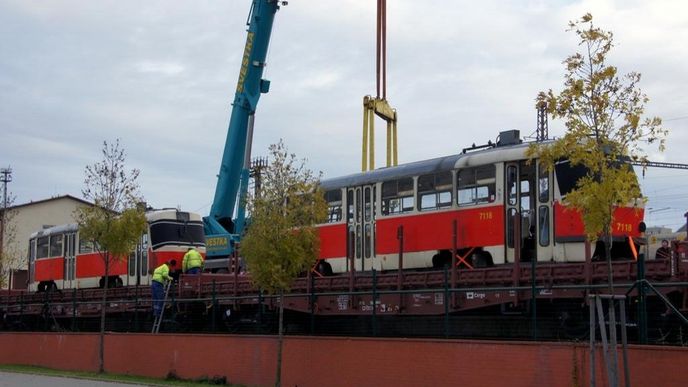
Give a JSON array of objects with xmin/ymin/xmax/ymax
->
[{"xmin": 0, "ymin": 249, "xmax": 688, "ymax": 338}]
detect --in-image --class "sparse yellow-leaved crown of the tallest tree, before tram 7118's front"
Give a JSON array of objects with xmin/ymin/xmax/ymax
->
[{"xmin": 529, "ymin": 14, "xmax": 667, "ymax": 239}]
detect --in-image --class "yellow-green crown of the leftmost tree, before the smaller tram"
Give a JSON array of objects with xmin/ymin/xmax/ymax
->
[{"xmin": 76, "ymin": 140, "xmax": 147, "ymax": 270}]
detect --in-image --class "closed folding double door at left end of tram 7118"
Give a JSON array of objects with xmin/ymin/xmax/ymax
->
[{"xmin": 347, "ymin": 185, "xmax": 379, "ymax": 271}]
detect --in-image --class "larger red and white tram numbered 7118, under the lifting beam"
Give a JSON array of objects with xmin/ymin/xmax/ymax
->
[{"xmin": 318, "ymin": 131, "xmax": 644, "ymax": 273}]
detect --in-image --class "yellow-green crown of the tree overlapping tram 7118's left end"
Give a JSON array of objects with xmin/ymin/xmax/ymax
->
[{"xmin": 241, "ymin": 141, "xmax": 327, "ymax": 294}]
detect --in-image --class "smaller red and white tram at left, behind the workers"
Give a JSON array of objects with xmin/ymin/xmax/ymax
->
[{"xmin": 28, "ymin": 209, "xmax": 205, "ymax": 291}]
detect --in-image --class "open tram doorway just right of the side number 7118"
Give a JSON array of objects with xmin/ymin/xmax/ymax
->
[{"xmin": 504, "ymin": 161, "xmax": 537, "ymax": 262}]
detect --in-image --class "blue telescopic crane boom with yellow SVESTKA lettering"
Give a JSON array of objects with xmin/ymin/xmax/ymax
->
[{"xmin": 203, "ymin": 0, "xmax": 286, "ymax": 270}]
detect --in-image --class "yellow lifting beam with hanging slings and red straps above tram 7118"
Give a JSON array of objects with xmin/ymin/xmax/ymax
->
[{"xmin": 361, "ymin": 0, "xmax": 398, "ymax": 172}]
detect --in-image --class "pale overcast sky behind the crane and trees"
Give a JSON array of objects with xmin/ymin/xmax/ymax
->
[{"xmin": 0, "ymin": 0, "xmax": 688, "ymax": 228}]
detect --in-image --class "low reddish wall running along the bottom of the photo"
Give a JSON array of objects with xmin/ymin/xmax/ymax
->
[{"xmin": 0, "ymin": 333, "xmax": 688, "ymax": 387}]
